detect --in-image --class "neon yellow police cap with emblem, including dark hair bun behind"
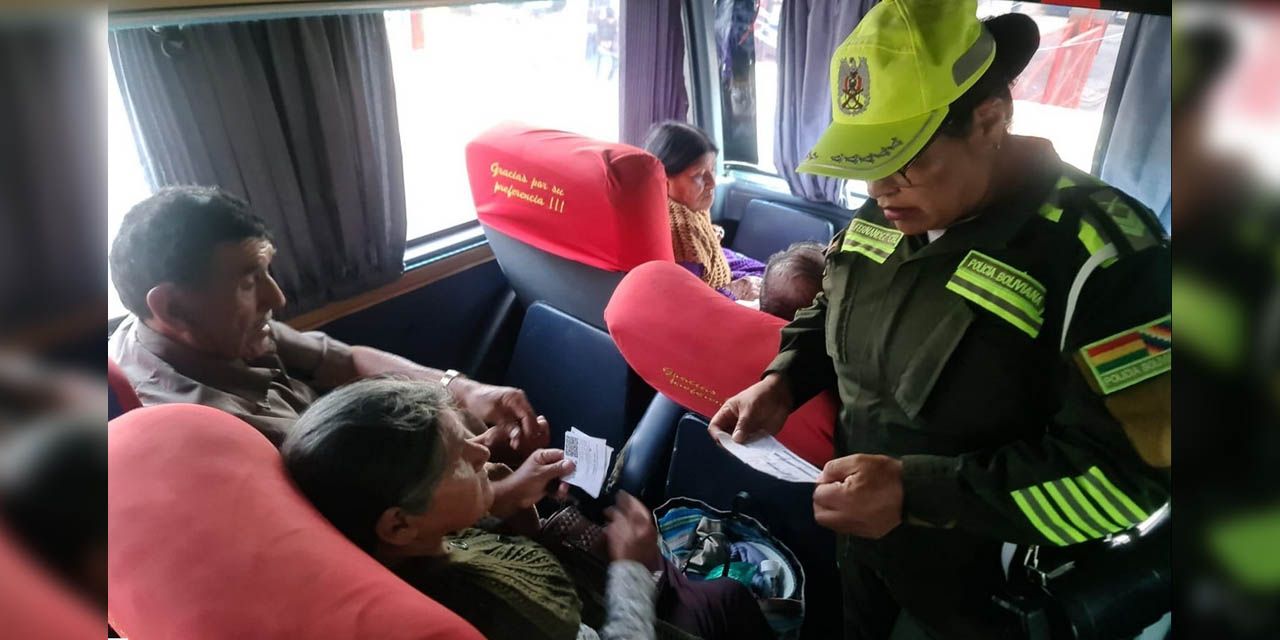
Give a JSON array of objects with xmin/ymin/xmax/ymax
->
[{"xmin": 796, "ymin": 0, "xmax": 1039, "ymax": 180}]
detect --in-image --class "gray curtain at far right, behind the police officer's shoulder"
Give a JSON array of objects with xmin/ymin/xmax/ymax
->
[{"xmin": 1093, "ymin": 13, "xmax": 1172, "ymax": 229}]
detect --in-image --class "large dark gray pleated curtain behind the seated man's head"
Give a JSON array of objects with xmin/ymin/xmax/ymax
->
[{"xmin": 110, "ymin": 14, "xmax": 406, "ymax": 317}]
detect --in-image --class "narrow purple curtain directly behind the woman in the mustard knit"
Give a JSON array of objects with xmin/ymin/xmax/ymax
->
[{"xmin": 618, "ymin": 0, "xmax": 689, "ymax": 145}]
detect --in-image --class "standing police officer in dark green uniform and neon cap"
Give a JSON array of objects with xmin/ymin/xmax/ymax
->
[{"xmin": 712, "ymin": 0, "xmax": 1172, "ymax": 637}]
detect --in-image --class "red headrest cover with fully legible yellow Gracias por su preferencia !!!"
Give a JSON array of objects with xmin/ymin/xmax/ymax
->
[{"xmin": 467, "ymin": 123, "xmax": 675, "ymax": 271}]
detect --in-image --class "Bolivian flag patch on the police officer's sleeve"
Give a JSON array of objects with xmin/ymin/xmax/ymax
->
[{"xmin": 1080, "ymin": 315, "xmax": 1174, "ymax": 394}]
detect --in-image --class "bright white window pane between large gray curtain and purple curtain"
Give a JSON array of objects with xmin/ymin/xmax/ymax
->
[{"xmin": 385, "ymin": 0, "xmax": 621, "ymax": 241}]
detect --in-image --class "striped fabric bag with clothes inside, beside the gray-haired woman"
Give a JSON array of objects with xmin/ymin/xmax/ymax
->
[{"xmin": 653, "ymin": 498, "xmax": 804, "ymax": 640}]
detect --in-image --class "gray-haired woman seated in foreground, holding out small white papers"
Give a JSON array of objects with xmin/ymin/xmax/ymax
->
[{"xmin": 280, "ymin": 379, "xmax": 772, "ymax": 640}]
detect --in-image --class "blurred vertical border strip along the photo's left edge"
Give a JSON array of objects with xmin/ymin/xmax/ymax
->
[{"xmin": 0, "ymin": 3, "xmax": 108, "ymax": 639}]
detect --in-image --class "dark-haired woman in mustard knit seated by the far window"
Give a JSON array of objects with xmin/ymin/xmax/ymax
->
[{"xmin": 644, "ymin": 120, "xmax": 764, "ymax": 301}]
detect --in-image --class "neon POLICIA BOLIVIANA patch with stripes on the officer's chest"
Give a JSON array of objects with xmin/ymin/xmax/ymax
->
[{"xmin": 947, "ymin": 251, "xmax": 1044, "ymax": 338}]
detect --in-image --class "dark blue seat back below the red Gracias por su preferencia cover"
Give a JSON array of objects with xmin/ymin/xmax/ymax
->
[{"xmin": 506, "ymin": 302, "xmax": 655, "ymax": 451}]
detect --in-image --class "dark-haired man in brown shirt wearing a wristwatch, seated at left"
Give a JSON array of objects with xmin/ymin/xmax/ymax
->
[{"xmin": 108, "ymin": 187, "xmax": 550, "ymax": 452}]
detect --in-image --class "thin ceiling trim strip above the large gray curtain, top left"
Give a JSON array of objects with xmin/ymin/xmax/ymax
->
[{"xmin": 108, "ymin": 0, "xmax": 521, "ymax": 29}]
